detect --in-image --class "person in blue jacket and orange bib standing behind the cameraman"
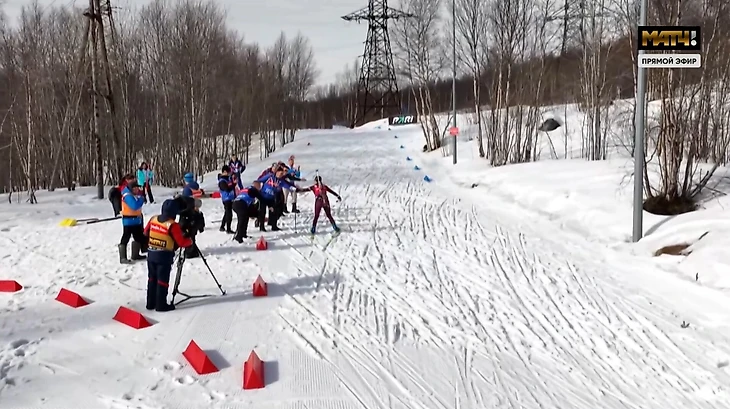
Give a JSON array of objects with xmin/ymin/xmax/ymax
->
[{"xmin": 119, "ymin": 181, "xmax": 147, "ymax": 264}]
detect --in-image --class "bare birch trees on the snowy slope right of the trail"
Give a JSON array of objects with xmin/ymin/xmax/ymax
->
[{"xmin": 308, "ymin": 0, "xmax": 730, "ymax": 213}]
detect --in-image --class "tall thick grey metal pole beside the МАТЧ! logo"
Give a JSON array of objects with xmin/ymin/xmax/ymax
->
[{"xmin": 633, "ymin": 0, "xmax": 647, "ymax": 243}]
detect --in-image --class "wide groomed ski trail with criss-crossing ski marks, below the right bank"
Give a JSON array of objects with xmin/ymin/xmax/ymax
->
[{"xmin": 0, "ymin": 126, "xmax": 730, "ymax": 409}]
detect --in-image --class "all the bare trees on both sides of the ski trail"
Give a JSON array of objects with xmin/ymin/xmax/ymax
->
[{"xmin": 0, "ymin": 0, "xmax": 730, "ymax": 215}]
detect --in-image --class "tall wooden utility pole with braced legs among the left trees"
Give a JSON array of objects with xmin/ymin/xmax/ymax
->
[{"xmin": 82, "ymin": 0, "xmax": 122, "ymax": 199}]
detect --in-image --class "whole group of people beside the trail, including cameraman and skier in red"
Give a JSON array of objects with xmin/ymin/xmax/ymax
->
[{"xmin": 109, "ymin": 156, "xmax": 341, "ymax": 312}]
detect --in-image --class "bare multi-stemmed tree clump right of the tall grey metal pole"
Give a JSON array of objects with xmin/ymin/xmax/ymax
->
[{"xmin": 645, "ymin": 0, "xmax": 730, "ymax": 214}]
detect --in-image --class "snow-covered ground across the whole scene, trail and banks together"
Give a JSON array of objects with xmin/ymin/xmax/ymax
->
[{"xmin": 0, "ymin": 116, "xmax": 730, "ymax": 409}]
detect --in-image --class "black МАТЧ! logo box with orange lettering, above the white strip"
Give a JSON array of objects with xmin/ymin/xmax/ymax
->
[{"xmin": 638, "ymin": 26, "xmax": 702, "ymax": 51}]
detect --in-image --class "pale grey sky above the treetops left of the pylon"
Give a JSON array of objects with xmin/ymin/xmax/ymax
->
[{"xmin": 0, "ymin": 0, "xmax": 367, "ymax": 84}]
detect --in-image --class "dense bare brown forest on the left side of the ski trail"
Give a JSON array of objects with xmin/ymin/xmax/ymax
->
[{"xmin": 0, "ymin": 0, "xmax": 317, "ymax": 194}]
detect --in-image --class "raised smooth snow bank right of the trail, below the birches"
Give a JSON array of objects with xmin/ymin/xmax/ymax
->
[{"xmin": 400, "ymin": 101, "xmax": 730, "ymax": 289}]
